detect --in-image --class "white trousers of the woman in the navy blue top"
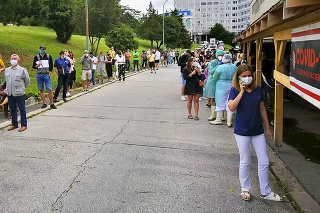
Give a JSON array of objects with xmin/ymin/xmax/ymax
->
[{"xmin": 235, "ymin": 134, "xmax": 271, "ymax": 195}]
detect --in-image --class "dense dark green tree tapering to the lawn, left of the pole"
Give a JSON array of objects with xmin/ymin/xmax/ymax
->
[{"xmin": 46, "ymin": 0, "xmax": 74, "ymax": 43}]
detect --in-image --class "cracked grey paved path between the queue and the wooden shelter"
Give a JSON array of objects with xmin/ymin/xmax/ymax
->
[{"xmin": 0, "ymin": 67, "xmax": 304, "ymax": 213}]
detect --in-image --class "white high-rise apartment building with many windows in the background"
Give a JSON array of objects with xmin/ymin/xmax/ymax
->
[{"xmin": 174, "ymin": 0, "xmax": 251, "ymax": 41}]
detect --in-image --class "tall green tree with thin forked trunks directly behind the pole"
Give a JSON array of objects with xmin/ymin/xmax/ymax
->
[{"xmin": 74, "ymin": 0, "xmax": 122, "ymax": 54}]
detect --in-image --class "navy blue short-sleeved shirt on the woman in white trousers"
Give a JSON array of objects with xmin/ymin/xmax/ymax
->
[{"xmin": 229, "ymin": 86, "xmax": 264, "ymax": 136}]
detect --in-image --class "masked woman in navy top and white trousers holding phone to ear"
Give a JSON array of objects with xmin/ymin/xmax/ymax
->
[{"xmin": 228, "ymin": 64, "xmax": 283, "ymax": 201}]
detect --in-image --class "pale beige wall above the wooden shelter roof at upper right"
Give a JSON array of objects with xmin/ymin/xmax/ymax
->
[{"xmin": 250, "ymin": 0, "xmax": 281, "ymax": 24}]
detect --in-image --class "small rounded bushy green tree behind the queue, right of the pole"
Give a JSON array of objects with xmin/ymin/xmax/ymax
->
[{"xmin": 105, "ymin": 24, "xmax": 139, "ymax": 51}]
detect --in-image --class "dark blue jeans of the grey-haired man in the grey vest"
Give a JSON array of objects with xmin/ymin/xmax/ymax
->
[{"xmin": 8, "ymin": 95, "xmax": 27, "ymax": 127}]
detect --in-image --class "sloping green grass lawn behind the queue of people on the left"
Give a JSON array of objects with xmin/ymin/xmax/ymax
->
[{"xmin": 0, "ymin": 24, "xmax": 230, "ymax": 97}]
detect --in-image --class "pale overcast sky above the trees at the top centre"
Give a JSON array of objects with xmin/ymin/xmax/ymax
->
[{"xmin": 120, "ymin": 0, "xmax": 174, "ymax": 14}]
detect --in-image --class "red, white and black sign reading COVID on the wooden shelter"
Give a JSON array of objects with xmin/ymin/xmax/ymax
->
[{"xmin": 290, "ymin": 23, "xmax": 320, "ymax": 109}]
